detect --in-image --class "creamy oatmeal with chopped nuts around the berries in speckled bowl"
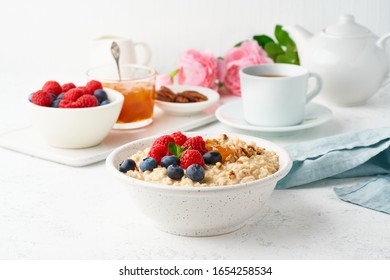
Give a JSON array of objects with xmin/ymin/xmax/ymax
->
[{"xmin": 120, "ymin": 134, "xmax": 279, "ymax": 187}]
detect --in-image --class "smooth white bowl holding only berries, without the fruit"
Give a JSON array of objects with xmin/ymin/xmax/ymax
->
[{"xmin": 27, "ymin": 88, "xmax": 123, "ymax": 149}]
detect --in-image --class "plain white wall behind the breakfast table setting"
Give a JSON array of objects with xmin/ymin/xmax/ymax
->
[{"xmin": 0, "ymin": 0, "xmax": 390, "ymax": 84}]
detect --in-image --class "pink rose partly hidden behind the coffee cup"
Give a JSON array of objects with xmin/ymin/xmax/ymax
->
[{"xmin": 218, "ymin": 40, "xmax": 273, "ymax": 96}]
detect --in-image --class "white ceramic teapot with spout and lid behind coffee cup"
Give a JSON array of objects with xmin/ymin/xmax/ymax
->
[{"xmin": 285, "ymin": 15, "xmax": 390, "ymax": 106}]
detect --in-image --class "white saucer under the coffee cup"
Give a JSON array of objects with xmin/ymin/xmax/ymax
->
[{"xmin": 215, "ymin": 100, "xmax": 332, "ymax": 134}]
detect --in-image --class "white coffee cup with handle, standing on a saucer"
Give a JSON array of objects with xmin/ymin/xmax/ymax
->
[{"xmin": 240, "ymin": 63, "xmax": 322, "ymax": 127}]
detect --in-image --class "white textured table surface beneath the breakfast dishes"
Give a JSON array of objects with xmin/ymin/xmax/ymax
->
[{"xmin": 0, "ymin": 77, "xmax": 390, "ymax": 259}]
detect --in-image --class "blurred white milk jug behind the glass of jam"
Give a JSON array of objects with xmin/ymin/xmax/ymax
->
[{"xmin": 89, "ymin": 36, "xmax": 152, "ymax": 67}]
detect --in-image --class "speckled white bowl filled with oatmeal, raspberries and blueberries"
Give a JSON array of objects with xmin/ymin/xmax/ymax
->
[{"xmin": 106, "ymin": 132, "xmax": 291, "ymax": 236}]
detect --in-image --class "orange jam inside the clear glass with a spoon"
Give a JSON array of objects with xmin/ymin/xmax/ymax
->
[{"xmin": 103, "ymin": 82, "xmax": 155, "ymax": 123}]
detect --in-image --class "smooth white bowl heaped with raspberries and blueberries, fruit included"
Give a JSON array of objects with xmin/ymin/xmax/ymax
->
[{"xmin": 26, "ymin": 80, "xmax": 124, "ymax": 149}]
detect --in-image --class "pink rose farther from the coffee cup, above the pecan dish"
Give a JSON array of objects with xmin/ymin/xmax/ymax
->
[{"xmin": 178, "ymin": 49, "xmax": 218, "ymax": 89}]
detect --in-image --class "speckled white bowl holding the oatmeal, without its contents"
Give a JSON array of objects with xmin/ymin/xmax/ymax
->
[{"xmin": 106, "ymin": 133, "xmax": 291, "ymax": 236}]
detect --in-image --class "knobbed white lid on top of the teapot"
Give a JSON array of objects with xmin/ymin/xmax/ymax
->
[{"xmin": 324, "ymin": 15, "xmax": 372, "ymax": 38}]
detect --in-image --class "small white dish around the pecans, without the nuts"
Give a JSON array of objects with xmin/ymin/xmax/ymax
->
[{"xmin": 155, "ymin": 85, "xmax": 219, "ymax": 115}]
